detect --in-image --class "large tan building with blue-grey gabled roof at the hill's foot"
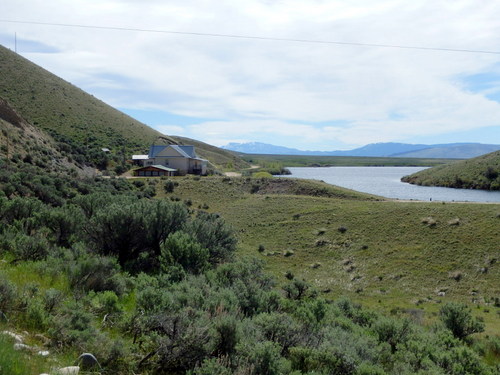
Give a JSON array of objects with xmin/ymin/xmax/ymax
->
[{"xmin": 138, "ymin": 145, "xmax": 208, "ymax": 175}]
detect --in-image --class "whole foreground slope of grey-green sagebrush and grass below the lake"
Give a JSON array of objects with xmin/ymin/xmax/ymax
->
[{"xmin": 0, "ymin": 159, "xmax": 500, "ymax": 375}]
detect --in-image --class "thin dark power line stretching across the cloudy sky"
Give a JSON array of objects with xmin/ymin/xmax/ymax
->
[{"xmin": 0, "ymin": 19, "xmax": 500, "ymax": 55}]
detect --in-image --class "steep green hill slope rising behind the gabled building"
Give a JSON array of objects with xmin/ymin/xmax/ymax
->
[{"xmin": 0, "ymin": 46, "xmax": 248, "ymax": 172}]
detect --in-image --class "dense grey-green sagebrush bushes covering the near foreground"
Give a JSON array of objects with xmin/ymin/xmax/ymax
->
[{"xmin": 0, "ymin": 156, "xmax": 499, "ymax": 375}]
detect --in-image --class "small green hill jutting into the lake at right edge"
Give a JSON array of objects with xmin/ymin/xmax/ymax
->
[{"xmin": 402, "ymin": 151, "xmax": 500, "ymax": 190}]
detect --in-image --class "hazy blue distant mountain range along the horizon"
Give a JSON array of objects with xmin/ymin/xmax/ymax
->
[{"xmin": 222, "ymin": 142, "xmax": 500, "ymax": 159}]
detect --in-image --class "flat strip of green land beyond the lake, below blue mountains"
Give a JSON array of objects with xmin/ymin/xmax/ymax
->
[{"xmin": 238, "ymin": 154, "xmax": 457, "ymax": 167}]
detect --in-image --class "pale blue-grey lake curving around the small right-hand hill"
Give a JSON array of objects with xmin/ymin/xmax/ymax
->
[{"xmin": 285, "ymin": 167, "xmax": 500, "ymax": 202}]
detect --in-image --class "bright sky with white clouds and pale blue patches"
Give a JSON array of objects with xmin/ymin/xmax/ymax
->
[{"xmin": 0, "ymin": 0, "xmax": 500, "ymax": 150}]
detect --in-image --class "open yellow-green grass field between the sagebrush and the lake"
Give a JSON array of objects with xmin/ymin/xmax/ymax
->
[{"xmin": 159, "ymin": 177, "xmax": 500, "ymax": 334}]
